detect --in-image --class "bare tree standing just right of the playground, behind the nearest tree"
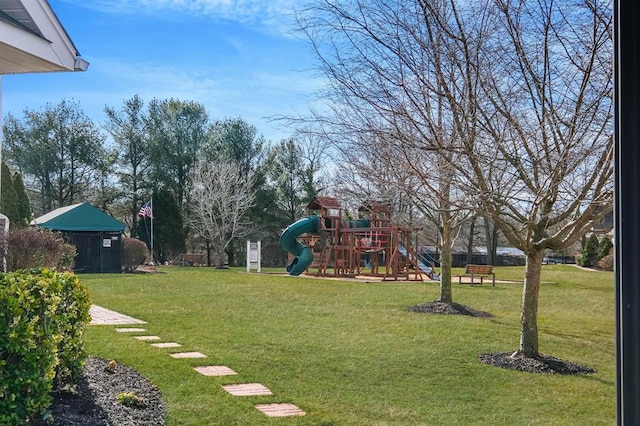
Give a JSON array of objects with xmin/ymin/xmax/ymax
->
[{"xmin": 298, "ymin": 0, "xmax": 477, "ymax": 303}]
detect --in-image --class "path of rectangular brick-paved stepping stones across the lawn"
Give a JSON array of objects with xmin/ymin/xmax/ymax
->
[{"xmin": 89, "ymin": 305, "xmax": 306, "ymax": 417}]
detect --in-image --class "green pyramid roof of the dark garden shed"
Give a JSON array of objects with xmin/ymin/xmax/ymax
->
[{"xmin": 31, "ymin": 203, "xmax": 124, "ymax": 232}]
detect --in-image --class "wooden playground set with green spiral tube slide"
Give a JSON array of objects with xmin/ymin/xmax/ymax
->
[{"xmin": 280, "ymin": 197, "xmax": 439, "ymax": 281}]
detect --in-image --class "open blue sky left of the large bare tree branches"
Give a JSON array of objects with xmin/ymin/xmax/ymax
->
[{"xmin": 2, "ymin": 0, "xmax": 322, "ymax": 142}]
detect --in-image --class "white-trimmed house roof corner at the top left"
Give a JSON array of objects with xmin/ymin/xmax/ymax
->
[{"xmin": 0, "ymin": 0, "xmax": 89, "ymax": 75}]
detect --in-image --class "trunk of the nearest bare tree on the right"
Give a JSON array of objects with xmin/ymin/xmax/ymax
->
[{"xmin": 512, "ymin": 250, "xmax": 544, "ymax": 358}]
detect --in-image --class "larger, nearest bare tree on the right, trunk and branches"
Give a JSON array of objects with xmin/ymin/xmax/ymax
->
[{"xmin": 462, "ymin": 0, "xmax": 613, "ymax": 357}]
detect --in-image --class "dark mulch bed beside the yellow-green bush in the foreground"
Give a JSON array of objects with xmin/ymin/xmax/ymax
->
[{"xmin": 40, "ymin": 356, "xmax": 164, "ymax": 426}]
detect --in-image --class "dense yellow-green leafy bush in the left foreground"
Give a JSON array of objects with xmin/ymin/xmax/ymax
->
[{"xmin": 0, "ymin": 269, "xmax": 90, "ymax": 425}]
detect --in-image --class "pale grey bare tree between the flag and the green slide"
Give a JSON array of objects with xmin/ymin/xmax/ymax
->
[{"xmin": 191, "ymin": 159, "xmax": 255, "ymax": 267}]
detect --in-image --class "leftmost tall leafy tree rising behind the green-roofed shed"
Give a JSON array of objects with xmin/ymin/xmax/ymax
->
[{"xmin": 4, "ymin": 100, "xmax": 104, "ymax": 211}]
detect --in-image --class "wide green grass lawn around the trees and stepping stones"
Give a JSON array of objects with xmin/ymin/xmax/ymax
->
[{"xmin": 80, "ymin": 265, "xmax": 615, "ymax": 426}]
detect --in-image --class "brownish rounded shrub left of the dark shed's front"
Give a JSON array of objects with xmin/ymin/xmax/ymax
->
[{"xmin": 7, "ymin": 228, "xmax": 70, "ymax": 271}]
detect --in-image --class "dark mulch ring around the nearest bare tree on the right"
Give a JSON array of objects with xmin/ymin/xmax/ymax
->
[{"xmin": 478, "ymin": 352, "xmax": 596, "ymax": 374}]
